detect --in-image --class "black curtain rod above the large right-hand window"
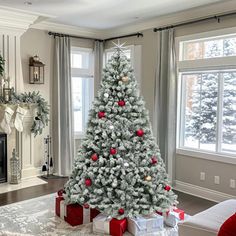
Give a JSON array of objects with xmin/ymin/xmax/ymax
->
[{"xmin": 153, "ymin": 12, "xmax": 236, "ymax": 32}]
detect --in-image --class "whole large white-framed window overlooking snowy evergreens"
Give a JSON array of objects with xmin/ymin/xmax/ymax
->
[{"xmin": 177, "ymin": 30, "xmax": 236, "ymax": 155}]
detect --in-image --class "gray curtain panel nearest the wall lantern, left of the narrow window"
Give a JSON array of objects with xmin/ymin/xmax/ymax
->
[{"xmin": 52, "ymin": 37, "xmax": 74, "ymax": 176}]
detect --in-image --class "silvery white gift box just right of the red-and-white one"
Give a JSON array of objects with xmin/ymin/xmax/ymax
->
[{"xmin": 128, "ymin": 214, "xmax": 164, "ymax": 236}]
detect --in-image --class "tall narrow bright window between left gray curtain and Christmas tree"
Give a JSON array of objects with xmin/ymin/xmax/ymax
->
[{"xmin": 71, "ymin": 47, "xmax": 94, "ymax": 138}]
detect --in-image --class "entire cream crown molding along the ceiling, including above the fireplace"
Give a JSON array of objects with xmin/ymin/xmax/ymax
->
[{"xmin": 0, "ymin": 0, "xmax": 236, "ymax": 39}]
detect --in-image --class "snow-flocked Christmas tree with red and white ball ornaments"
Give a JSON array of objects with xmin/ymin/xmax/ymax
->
[{"xmin": 65, "ymin": 42, "xmax": 177, "ymax": 219}]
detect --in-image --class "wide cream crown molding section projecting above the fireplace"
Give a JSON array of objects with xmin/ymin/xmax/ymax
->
[{"xmin": 0, "ymin": 7, "xmax": 38, "ymax": 34}]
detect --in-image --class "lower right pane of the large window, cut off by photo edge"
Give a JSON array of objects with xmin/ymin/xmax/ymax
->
[{"xmin": 222, "ymin": 72, "xmax": 236, "ymax": 152}]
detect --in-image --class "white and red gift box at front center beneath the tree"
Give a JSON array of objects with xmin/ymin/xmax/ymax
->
[{"xmin": 93, "ymin": 214, "xmax": 127, "ymax": 236}]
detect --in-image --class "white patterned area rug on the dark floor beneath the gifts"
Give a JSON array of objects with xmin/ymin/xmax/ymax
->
[{"xmin": 0, "ymin": 194, "xmax": 178, "ymax": 236}]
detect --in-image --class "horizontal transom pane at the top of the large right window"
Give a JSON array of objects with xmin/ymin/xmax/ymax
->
[{"xmin": 182, "ymin": 36, "xmax": 236, "ymax": 60}]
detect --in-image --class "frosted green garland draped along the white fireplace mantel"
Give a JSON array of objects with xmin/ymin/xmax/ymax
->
[{"xmin": 0, "ymin": 91, "xmax": 49, "ymax": 136}]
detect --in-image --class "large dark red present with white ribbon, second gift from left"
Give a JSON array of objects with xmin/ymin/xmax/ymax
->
[{"xmin": 65, "ymin": 204, "xmax": 100, "ymax": 226}]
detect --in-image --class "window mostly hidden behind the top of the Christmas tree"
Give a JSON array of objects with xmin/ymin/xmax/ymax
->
[{"xmin": 104, "ymin": 45, "xmax": 142, "ymax": 89}]
